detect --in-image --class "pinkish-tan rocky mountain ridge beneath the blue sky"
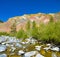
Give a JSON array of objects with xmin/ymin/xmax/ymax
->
[{"xmin": 0, "ymin": 13, "xmax": 60, "ymax": 32}]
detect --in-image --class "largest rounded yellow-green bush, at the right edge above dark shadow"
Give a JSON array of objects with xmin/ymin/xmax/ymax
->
[{"xmin": 39, "ymin": 22, "xmax": 60, "ymax": 44}]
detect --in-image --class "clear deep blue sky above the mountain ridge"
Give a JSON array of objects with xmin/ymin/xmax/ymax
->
[{"xmin": 0, "ymin": 0, "xmax": 60, "ymax": 22}]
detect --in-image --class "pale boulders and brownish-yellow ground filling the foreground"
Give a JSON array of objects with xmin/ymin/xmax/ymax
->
[{"xmin": 0, "ymin": 36, "xmax": 60, "ymax": 57}]
